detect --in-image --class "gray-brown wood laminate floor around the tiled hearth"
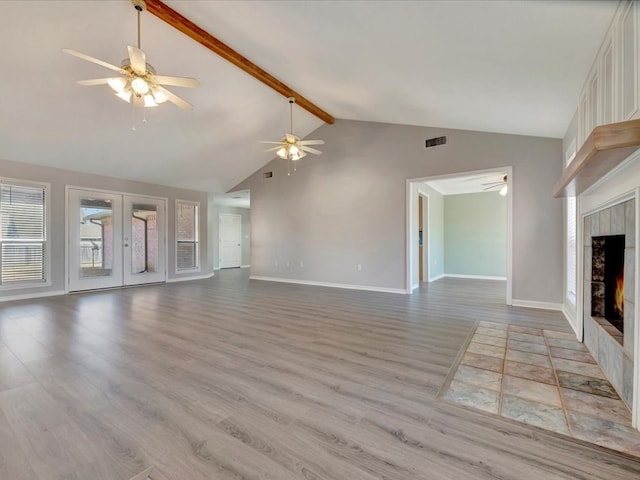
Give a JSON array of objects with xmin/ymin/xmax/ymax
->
[{"xmin": 0, "ymin": 271, "xmax": 640, "ymax": 480}]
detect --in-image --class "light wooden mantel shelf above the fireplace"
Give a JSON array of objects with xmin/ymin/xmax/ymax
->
[{"xmin": 553, "ymin": 119, "xmax": 640, "ymax": 197}]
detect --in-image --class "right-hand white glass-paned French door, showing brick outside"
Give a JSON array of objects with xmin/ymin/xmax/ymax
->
[{"xmin": 122, "ymin": 195, "xmax": 167, "ymax": 285}]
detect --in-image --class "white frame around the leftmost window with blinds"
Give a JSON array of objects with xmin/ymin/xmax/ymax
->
[{"xmin": 0, "ymin": 176, "xmax": 53, "ymax": 291}]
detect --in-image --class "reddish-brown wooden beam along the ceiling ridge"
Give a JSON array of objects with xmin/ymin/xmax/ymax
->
[{"xmin": 146, "ymin": 0, "xmax": 335, "ymax": 123}]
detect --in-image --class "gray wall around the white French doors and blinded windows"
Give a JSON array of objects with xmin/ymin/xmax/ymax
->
[{"xmin": 0, "ymin": 156, "xmax": 212, "ymax": 298}]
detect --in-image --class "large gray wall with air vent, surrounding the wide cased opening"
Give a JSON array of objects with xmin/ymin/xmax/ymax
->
[{"xmin": 234, "ymin": 120, "xmax": 562, "ymax": 303}]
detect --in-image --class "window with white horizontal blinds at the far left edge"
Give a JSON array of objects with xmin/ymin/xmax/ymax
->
[{"xmin": 0, "ymin": 179, "xmax": 48, "ymax": 288}]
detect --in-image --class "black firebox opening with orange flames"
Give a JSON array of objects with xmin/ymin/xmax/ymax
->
[{"xmin": 591, "ymin": 235, "xmax": 625, "ymax": 333}]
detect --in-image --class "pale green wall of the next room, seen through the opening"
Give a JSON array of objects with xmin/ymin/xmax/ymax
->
[{"xmin": 444, "ymin": 191, "xmax": 507, "ymax": 277}]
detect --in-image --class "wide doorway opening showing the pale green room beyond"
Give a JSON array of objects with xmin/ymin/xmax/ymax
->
[{"xmin": 406, "ymin": 167, "xmax": 513, "ymax": 305}]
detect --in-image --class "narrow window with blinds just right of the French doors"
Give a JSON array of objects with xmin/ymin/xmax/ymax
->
[{"xmin": 176, "ymin": 200, "xmax": 200, "ymax": 272}]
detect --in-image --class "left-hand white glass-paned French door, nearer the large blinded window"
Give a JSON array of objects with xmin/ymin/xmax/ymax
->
[{"xmin": 67, "ymin": 189, "xmax": 122, "ymax": 291}]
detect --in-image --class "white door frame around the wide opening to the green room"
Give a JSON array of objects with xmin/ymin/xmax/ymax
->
[{"xmin": 405, "ymin": 165, "xmax": 513, "ymax": 305}]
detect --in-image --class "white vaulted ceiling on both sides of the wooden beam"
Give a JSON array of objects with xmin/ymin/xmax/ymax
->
[{"xmin": 0, "ymin": 0, "xmax": 616, "ymax": 193}]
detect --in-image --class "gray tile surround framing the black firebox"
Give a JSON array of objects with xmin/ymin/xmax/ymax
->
[{"xmin": 583, "ymin": 199, "xmax": 637, "ymax": 408}]
